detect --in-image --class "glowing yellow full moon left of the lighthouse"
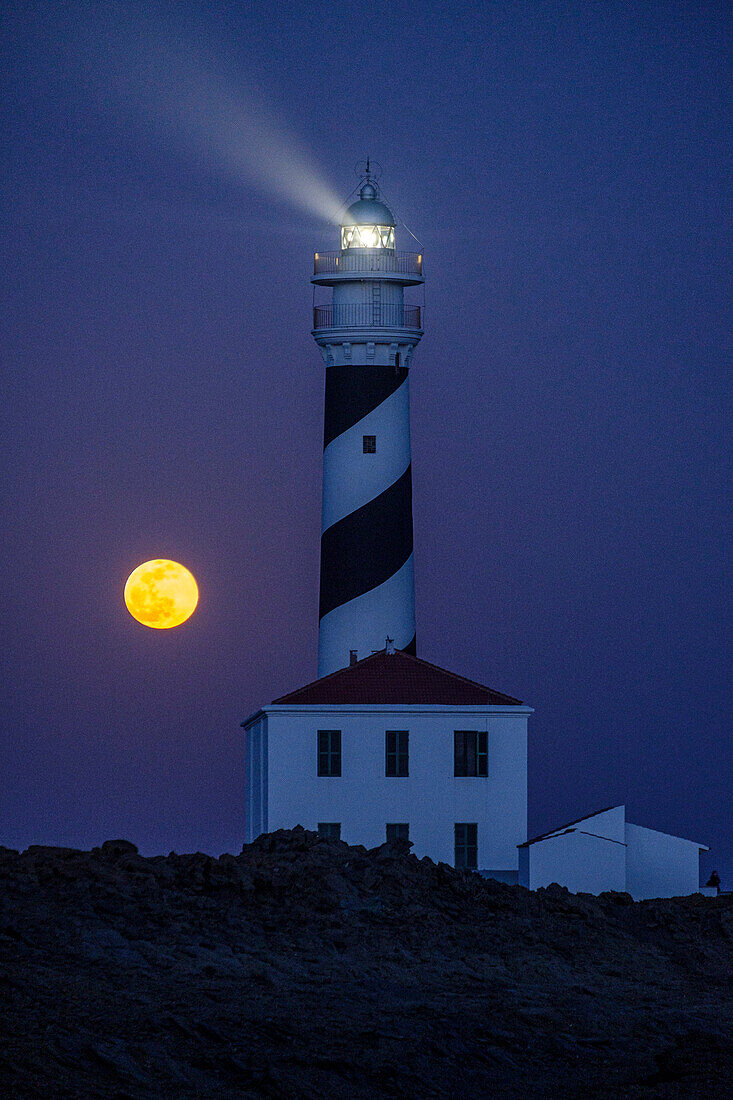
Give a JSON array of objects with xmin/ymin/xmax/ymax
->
[{"xmin": 124, "ymin": 558, "xmax": 198, "ymax": 630}]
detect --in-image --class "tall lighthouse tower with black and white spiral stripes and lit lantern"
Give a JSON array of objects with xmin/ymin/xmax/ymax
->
[{"xmin": 313, "ymin": 162, "xmax": 423, "ymax": 677}]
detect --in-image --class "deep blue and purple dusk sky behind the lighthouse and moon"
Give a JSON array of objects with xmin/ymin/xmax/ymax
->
[{"xmin": 0, "ymin": 0, "xmax": 733, "ymax": 875}]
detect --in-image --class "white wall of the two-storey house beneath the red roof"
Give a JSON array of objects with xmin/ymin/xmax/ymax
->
[{"xmin": 248, "ymin": 706, "xmax": 532, "ymax": 870}]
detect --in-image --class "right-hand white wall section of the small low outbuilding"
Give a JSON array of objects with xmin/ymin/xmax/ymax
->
[{"xmin": 626, "ymin": 825, "xmax": 701, "ymax": 901}]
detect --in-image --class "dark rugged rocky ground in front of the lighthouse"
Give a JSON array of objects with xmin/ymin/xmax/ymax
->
[{"xmin": 0, "ymin": 829, "xmax": 733, "ymax": 1100}]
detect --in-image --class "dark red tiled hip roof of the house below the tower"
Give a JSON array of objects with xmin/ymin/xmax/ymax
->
[{"xmin": 268, "ymin": 649, "xmax": 521, "ymax": 706}]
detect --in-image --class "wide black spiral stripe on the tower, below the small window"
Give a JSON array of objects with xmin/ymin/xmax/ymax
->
[{"xmin": 320, "ymin": 462, "xmax": 413, "ymax": 620}]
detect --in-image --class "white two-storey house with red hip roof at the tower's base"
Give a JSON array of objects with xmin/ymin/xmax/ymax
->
[{"xmin": 242, "ymin": 646, "xmax": 533, "ymax": 882}]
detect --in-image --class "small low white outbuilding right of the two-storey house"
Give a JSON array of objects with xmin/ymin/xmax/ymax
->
[{"xmin": 518, "ymin": 806, "xmax": 709, "ymax": 901}]
